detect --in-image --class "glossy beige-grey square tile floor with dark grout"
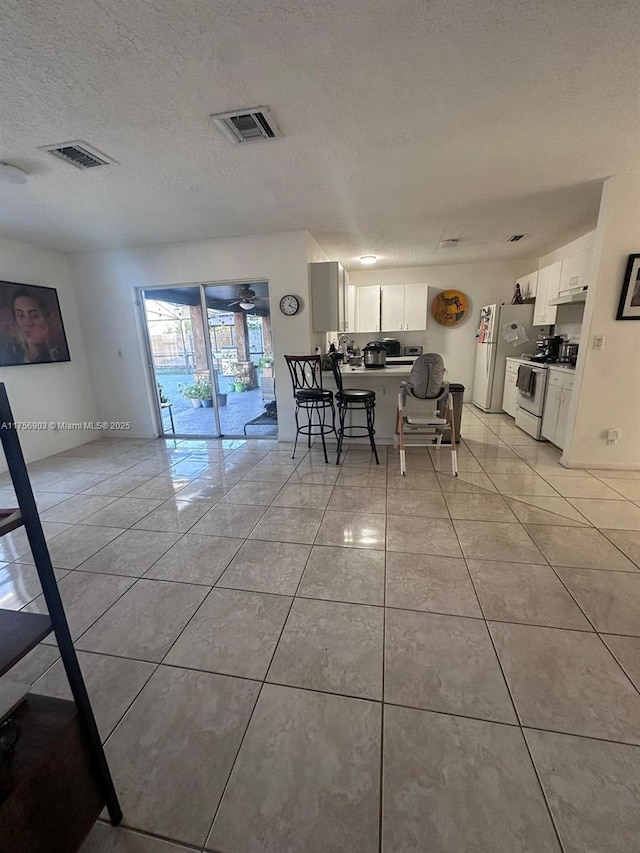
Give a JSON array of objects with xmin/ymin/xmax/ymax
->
[{"xmin": 0, "ymin": 407, "xmax": 640, "ymax": 853}]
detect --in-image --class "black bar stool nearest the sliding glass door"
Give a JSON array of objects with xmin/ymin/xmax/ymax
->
[{"xmin": 285, "ymin": 355, "xmax": 336, "ymax": 463}]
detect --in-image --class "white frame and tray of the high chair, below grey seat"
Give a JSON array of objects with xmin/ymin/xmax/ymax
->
[{"xmin": 393, "ymin": 382, "xmax": 458, "ymax": 477}]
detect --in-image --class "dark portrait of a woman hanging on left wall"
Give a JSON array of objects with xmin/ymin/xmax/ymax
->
[{"xmin": 0, "ymin": 281, "xmax": 71, "ymax": 367}]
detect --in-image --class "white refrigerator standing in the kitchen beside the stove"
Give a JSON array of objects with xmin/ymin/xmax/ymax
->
[{"xmin": 471, "ymin": 305, "xmax": 536, "ymax": 412}]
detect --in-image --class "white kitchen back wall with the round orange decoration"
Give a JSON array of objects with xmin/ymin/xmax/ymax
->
[{"xmin": 349, "ymin": 258, "xmax": 537, "ymax": 400}]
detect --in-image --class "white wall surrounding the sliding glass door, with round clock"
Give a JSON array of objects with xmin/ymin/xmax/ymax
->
[{"xmin": 69, "ymin": 231, "xmax": 311, "ymax": 440}]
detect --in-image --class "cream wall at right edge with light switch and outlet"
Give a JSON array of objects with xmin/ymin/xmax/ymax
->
[{"xmin": 563, "ymin": 174, "xmax": 640, "ymax": 469}]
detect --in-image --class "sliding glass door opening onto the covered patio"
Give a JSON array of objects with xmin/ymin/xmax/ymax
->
[{"xmin": 141, "ymin": 281, "xmax": 278, "ymax": 438}]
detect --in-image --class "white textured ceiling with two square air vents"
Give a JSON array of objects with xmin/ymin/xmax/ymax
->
[{"xmin": 0, "ymin": 0, "xmax": 640, "ymax": 268}]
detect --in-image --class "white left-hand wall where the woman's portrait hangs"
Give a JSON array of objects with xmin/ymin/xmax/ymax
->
[{"xmin": 0, "ymin": 240, "xmax": 97, "ymax": 470}]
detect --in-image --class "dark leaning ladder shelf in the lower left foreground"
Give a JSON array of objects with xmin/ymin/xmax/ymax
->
[{"xmin": 0, "ymin": 383, "xmax": 122, "ymax": 853}]
